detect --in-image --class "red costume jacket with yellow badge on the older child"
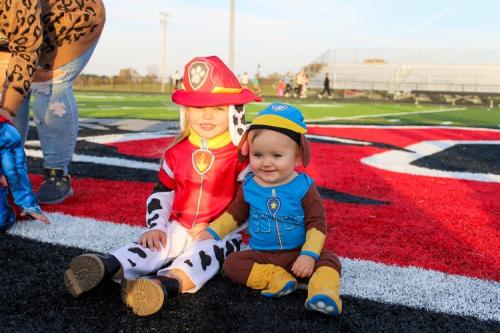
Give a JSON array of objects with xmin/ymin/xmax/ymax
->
[{"xmin": 158, "ymin": 133, "xmax": 247, "ymax": 229}]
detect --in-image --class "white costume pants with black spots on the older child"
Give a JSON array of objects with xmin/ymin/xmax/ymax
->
[{"xmin": 111, "ymin": 221, "xmax": 241, "ymax": 293}]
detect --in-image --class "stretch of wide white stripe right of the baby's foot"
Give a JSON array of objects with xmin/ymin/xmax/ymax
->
[{"xmin": 342, "ymin": 258, "xmax": 500, "ymax": 321}]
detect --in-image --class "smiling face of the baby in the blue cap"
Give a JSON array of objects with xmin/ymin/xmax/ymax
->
[{"xmin": 248, "ymin": 129, "xmax": 300, "ymax": 186}]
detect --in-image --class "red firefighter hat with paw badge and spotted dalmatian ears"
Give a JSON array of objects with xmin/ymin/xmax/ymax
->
[{"xmin": 172, "ymin": 56, "xmax": 261, "ymax": 145}]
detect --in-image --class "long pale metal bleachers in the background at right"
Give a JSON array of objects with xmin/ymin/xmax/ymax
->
[{"xmin": 306, "ymin": 50, "xmax": 500, "ymax": 95}]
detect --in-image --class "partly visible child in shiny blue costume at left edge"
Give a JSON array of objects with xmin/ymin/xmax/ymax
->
[{"xmin": 0, "ymin": 116, "xmax": 49, "ymax": 232}]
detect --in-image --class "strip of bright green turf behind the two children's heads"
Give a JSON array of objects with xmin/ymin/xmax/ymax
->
[{"xmin": 76, "ymin": 92, "xmax": 500, "ymax": 128}]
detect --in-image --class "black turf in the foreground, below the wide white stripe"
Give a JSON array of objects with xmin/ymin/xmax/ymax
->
[{"xmin": 0, "ymin": 235, "xmax": 500, "ymax": 333}]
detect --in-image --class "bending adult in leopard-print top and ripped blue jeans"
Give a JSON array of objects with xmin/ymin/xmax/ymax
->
[{"xmin": 0, "ymin": 0, "xmax": 105, "ymax": 204}]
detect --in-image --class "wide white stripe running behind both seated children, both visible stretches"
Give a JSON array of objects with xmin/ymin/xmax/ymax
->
[{"xmin": 8, "ymin": 213, "xmax": 500, "ymax": 321}]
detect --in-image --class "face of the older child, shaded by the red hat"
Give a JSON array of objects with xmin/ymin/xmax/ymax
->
[{"xmin": 186, "ymin": 106, "xmax": 229, "ymax": 139}]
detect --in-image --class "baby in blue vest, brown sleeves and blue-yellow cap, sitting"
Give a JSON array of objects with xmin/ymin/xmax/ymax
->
[{"xmin": 197, "ymin": 104, "xmax": 342, "ymax": 316}]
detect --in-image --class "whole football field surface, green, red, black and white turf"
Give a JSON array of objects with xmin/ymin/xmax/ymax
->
[{"xmin": 0, "ymin": 89, "xmax": 500, "ymax": 332}]
